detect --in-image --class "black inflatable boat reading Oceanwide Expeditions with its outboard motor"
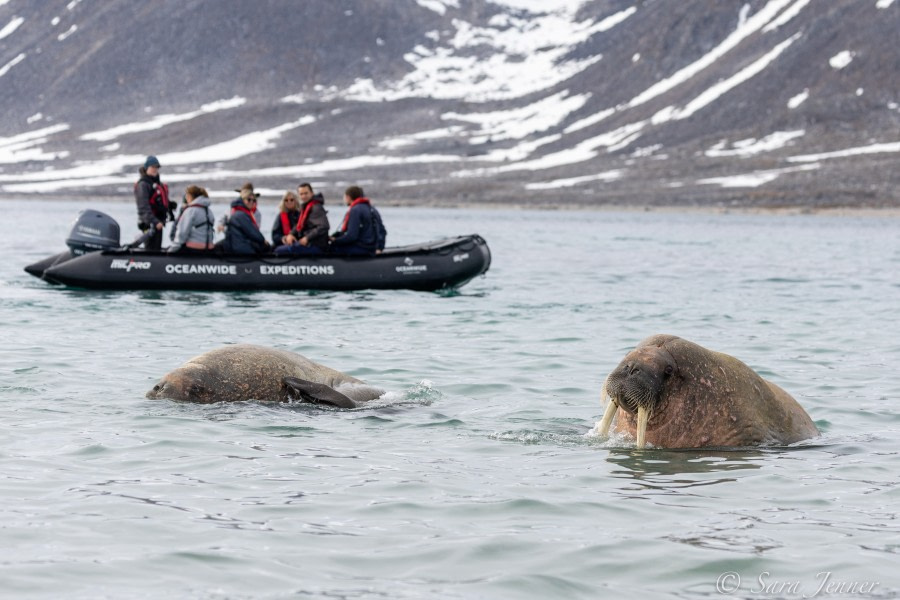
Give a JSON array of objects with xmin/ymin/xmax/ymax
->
[{"xmin": 25, "ymin": 210, "xmax": 491, "ymax": 291}]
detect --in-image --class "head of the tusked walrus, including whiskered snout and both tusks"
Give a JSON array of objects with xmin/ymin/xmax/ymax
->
[{"xmin": 598, "ymin": 344, "xmax": 678, "ymax": 448}]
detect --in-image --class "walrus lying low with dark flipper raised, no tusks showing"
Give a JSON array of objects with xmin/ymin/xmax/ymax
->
[{"xmin": 147, "ymin": 344, "xmax": 384, "ymax": 408}]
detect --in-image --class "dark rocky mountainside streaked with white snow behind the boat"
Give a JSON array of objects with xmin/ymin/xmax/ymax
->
[{"xmin": 0, "ymin": 0, "xmax": 900, "ymax": 207}]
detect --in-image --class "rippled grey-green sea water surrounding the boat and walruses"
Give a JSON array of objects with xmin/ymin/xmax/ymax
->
[{"xmin": 0, "ymin": 200, "xmax": 900, "ymax": 600}]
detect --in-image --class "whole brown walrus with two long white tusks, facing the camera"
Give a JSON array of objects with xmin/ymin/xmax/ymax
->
[{"xmin": 596, "ymin": 335, "xmax": 819, "ymax": 448}]
